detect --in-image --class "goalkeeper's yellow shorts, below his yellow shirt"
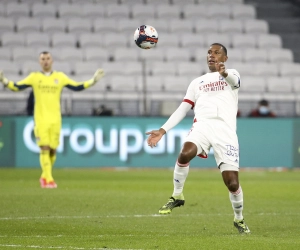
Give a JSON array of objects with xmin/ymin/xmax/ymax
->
[{"xmin": 34, "ymin": 124, "xmax": 61, "ymax": 149}]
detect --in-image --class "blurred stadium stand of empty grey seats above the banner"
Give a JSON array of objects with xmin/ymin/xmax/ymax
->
[{"xmin": 0, "ymin": 0, "xmax": 300, "ymax": 117}]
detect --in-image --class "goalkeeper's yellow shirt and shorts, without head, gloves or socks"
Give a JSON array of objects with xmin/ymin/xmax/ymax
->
[{"xmin": 7, "ymin": 71, "xmax": 94, "ymax": 148}]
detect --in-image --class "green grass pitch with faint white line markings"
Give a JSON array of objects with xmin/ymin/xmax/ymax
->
[{"xmin": 0, "ymin": 168, "xmax": 300, "ymax": 250}]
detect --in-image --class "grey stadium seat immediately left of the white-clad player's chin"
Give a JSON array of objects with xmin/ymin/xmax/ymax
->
[{"xmin": 177, "ymin": 62, "xmax": 206, "ymax": 79}]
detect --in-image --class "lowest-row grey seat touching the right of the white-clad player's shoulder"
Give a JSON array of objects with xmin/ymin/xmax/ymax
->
[{"xmin": 240, "ymin": 75, "xmax": 267, "ymax": 93}]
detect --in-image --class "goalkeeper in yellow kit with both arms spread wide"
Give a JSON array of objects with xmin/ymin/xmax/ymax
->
[{"xmin": 0, "ymin": 51, "xmax": 104, "ymax": 188}]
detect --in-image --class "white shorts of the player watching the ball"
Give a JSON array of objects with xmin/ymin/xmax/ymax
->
[{"xmin": 185, "ymin": 119, "xmax": 239, "ymax": 171}]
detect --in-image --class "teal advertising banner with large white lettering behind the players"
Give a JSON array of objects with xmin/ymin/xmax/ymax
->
[{"xmin": 0, "ymin": 117, "xmax": 300, "ymax": 168}]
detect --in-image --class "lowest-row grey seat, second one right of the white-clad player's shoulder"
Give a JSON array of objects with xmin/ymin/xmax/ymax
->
[{"xmin": 266, "ymin": 76, "xmax": 293, "ymax": 94}]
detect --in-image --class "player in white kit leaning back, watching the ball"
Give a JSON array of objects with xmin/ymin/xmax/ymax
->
[{"xmin": 146, "ymin": 43, "xmax": 250, "ymax": 234}]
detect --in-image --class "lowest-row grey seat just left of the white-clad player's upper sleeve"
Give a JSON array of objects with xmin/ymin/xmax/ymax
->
[{"xmin": 164, "ymin": 76, "xmax": 190, "ymax": 93}]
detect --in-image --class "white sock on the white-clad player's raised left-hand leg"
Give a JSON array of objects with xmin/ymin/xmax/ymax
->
[{"xmin": 172, "ymin": 161, "xmax": 190, "ymax": 196}]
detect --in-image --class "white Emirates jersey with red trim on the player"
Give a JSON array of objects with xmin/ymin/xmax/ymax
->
[{"xmin": 183, "ymin": 69, "xmax": 240, "ymax": 130}]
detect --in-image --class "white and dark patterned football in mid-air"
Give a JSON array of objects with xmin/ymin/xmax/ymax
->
[{"xmin": 133, "ymin": 25, "xmax": 158, "ymax": 49}]
